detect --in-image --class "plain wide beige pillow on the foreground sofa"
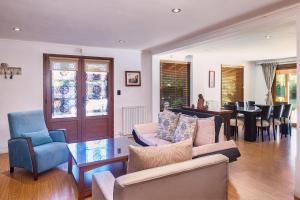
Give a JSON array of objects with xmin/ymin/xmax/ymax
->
[{"xmin": 127, "ymin": 140, "xmax": 193, "ymax": 173}]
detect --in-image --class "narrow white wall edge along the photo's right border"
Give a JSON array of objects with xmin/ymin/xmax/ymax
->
[{"xmin": 295, "ymin": 8, "xmax": 300, "ymax": 198}]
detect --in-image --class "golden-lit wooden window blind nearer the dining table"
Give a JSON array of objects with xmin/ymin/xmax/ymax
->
[{"xmin": 221, "ymin": 65, "xmax": 244, "ymax": 105}]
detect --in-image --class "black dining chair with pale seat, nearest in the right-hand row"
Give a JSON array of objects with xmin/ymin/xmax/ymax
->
[{"xmin": 256, "ymin": 105, "xmax": 272, "ymax": 141}]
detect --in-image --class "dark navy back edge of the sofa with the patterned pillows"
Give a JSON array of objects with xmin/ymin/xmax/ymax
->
[{"xmin": 171, "ymin": 109, "xmax": 223, "ymax": 142}]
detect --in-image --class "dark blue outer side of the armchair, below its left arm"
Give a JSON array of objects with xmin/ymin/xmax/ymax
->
[{"xmin": 8, "ymin": 137, "xmax": 36, "ymax": 173}]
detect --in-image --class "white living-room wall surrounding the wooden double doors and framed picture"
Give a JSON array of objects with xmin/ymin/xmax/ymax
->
[{"xmin": 0, "ymin": 39, "xmax": 151, "ymax": 152}]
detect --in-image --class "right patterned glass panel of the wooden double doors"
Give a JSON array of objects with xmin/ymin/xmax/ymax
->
[{"xmin": 85, "ymin": 60, "xmax": 109, "ymax": 117}]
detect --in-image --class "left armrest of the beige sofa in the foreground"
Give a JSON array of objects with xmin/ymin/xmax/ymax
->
[{"xmin": 92, "ymin": 171, "xmax": 115, "ymax": 200}]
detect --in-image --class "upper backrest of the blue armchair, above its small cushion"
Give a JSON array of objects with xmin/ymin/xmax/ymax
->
[{"xmin": 8, "ymin": 110, "xmax": 48, "ymax": 138}]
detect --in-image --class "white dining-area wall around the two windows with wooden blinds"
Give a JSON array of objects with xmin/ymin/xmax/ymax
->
[{"xmin": 152, "ymin": 53, "xmax": 259, "ymax": 120}]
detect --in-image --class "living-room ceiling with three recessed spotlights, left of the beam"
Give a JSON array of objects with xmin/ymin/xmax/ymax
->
[{"xmin": 0, "ymin": 0, "xmax": 299, "ymax": 50}]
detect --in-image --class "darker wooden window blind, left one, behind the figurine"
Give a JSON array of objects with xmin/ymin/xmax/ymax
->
[{"xmin": 160, "ymin": 61, "xmax": 190, "ymax": 110}]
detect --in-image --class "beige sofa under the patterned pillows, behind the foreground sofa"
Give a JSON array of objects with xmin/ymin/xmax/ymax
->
[{"xmin": 132, "ymin": 123, "xmax": 241, "ymax": 162}]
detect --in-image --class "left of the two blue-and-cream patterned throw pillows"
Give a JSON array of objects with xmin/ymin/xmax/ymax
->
[{"xmin": 156, "ymin": 110, "xmax": 179, "ymax": 142}]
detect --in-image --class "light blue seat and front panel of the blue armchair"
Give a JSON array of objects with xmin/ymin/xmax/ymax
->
[{"xmin": 33, "ymin": 142, "xmax": 68, "ymax": 173}]
